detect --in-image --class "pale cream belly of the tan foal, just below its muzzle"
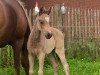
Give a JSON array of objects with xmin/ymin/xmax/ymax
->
[{"xmin": 45, "ymin": 37, "xmax": 55, "ymax": 54}]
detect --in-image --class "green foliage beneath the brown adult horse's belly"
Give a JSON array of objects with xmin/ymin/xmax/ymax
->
[{"xmin": 0, "ymin": 45, "xmax": 13, "ymax": 67}]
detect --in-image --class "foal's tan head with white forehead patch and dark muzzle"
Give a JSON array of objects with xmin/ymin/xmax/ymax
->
[{"xmin": 35, "ymin": 8, "xmax": 52, "ymax": 39}]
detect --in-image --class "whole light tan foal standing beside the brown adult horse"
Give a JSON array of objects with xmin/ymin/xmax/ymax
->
[{"xmin": 27, "ymin": 9, "xmax": 69, "ymax": 75}]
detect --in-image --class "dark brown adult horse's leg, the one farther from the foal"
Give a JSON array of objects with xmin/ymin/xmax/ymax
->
[{"xmin": 13, "ymin": 39, "xmax": 23, "ymax": 75}]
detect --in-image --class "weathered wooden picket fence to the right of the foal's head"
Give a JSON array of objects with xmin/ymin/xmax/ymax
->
[{"xmin": 51, "ymin": 5, "xmax": 100, "ymax": 40}]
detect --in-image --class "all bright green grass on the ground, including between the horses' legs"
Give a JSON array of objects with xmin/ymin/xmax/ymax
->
[{"xmin": 0, "ymin": 59, "xmax": 100, "ymax": 75}]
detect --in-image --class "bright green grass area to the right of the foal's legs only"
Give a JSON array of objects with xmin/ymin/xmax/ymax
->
[{"xmin": 69, "ymin": 60, "xmax": 100, "ymax": 75}]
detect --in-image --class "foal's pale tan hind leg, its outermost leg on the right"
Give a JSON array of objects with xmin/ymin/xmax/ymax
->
[{"xmin": 56, "ymin": 49, "xmax": 69, "ymax": 75}]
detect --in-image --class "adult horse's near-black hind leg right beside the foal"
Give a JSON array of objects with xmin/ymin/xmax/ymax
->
[{"xmin": 21, "ymin": 28, "xmax": 30, "ymax": 75}]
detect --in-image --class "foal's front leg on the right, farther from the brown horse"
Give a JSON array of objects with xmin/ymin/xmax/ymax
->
[{"xmin": 38, "ymin": 52, "xmax": 45, "ymax": 75}]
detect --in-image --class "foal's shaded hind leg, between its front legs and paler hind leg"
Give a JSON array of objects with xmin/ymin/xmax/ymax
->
[{"xmin": 49, "ymin": 53, "xmax": 59, "ymax": 75}]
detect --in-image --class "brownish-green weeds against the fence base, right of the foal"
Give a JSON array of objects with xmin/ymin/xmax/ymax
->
[{"xmin": 66, "ymin": 38, "xmax": 100, "ymax": 61}]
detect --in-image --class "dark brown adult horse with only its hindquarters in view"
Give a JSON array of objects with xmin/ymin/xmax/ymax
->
[{"xmin": 0, "ymin": 0, "xmax": 30, "ymax": 75}]
